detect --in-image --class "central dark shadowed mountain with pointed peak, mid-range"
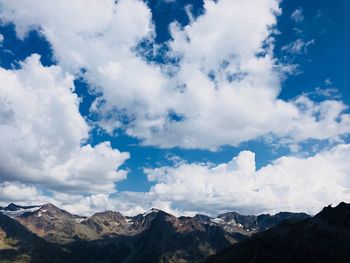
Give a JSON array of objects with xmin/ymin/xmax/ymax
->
[{"xmin": 69, "ymin": 210, "xmax": 246, "ymax": 263}]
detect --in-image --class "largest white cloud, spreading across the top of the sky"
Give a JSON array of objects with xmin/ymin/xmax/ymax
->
[{"xmin": 1, "ymin": 0, "xmax": 350, "ymax": 149}]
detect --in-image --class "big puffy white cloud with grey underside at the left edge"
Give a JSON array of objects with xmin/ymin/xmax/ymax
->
[{"xmin": 0, "ymin": 55, "xmax": 129, "ymax": 194}]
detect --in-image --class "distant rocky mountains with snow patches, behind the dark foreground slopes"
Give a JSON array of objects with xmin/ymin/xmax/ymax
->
[{"xmin": 0, "ymin": 204, "xmax": 309, "ymax": 263}]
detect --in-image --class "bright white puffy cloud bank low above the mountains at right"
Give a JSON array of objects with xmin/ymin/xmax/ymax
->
[{"xmin": 142, "ymin": 144, "xmax": 350, "ymax": 215}]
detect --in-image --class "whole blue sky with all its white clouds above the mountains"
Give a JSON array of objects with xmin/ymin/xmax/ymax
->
[{"xmin": 0, "ymin": 0, "xmax": 350, "ymax": 216}]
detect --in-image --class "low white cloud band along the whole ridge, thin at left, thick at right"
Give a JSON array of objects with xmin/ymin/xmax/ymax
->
[{"xmin": 0, "ymin": 144, "xmax": 350, "ymax": 216}]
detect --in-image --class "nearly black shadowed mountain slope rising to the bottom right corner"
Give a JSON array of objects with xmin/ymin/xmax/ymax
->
[{"xmin": 207, "ymin": 203, "xmax": 350, "ymax": 263}]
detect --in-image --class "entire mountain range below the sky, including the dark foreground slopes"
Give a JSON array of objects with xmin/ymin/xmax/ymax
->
[{"xmin": 0, "ymin": 203, "xmax": 350, "ymax": 263}]
